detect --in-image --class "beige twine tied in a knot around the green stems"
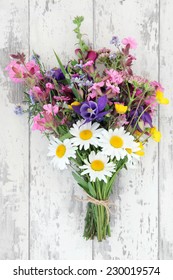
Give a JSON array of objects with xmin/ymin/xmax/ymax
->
[{"xmin": 75, "ymin": 193, "xmax": 115, "ymax": 224}]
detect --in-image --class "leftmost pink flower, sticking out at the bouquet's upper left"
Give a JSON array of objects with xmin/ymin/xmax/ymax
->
[{"xmin": 5, "ymin": 60, "xmax": 26, "ymax": 83}]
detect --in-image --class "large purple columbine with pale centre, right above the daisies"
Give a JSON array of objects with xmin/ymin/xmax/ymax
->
[{"xmin": 73, "ymin": 95, "xmax": 108, "ymax": 123}]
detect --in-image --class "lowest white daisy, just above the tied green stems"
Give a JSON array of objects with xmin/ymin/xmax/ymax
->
[{"xmin": 80, "ymin": 151, "xmax": 116, "ymax": 183}]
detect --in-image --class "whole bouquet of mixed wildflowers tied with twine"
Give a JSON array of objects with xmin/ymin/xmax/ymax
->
[{"xmin": 6, "ymin": 17, "xmax": 169, "ymax": 241}]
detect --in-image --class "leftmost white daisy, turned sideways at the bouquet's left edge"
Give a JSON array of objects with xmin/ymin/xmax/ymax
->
[{"xmin": 48, "ymin": 137, "xmax": 76, "ymax": 170}]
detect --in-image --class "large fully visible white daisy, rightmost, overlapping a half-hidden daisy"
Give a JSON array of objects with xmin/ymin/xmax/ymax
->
[{"xmin": 100, "ymin": 127, "xmax": 138, "ymax": 160}]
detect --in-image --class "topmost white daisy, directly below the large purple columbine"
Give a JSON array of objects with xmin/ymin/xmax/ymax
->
[{"xmin": 70, "ymin": 120, "xmax": 103, "ymax": 150}]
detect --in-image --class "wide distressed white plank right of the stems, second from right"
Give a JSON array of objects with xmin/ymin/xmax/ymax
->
[{"xmin": 94, "ymin": 0, "xmax": 159, "ymax": 259}]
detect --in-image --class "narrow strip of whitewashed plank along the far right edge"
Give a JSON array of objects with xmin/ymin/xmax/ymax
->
[{"xmin": 159, "ymin": 0, "xmax": 173, "ymax": 259}]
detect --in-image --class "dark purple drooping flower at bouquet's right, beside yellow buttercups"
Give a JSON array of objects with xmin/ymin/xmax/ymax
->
[{"xmin": 128, "ymin": 106, "xmax": 153, "ymax": 131}]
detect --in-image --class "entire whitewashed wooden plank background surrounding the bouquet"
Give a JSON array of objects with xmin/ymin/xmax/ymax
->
[{"xmin": 0, "ymin": 0, "xmax": 173, "ymax": 259}]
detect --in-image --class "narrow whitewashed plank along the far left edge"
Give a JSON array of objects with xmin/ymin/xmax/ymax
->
[{"xmin": 0, "ymin": 0, "xmax": 28, "ymax": 259}]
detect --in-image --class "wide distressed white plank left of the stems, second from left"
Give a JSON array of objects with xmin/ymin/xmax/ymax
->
[{"xmin": 30, "ymin": 0, "xmax": 93, "ymax": 259}]
